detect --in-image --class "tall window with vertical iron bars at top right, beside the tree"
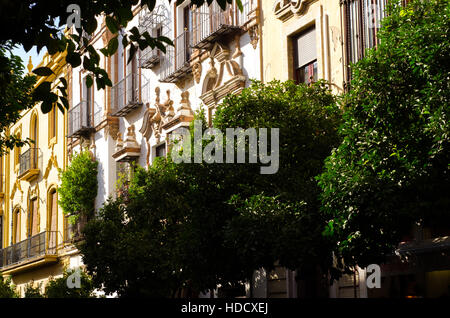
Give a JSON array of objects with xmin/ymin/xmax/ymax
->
[{"xmin": 342, "ymin": 0, "xmax": 386, "ymax": 81}]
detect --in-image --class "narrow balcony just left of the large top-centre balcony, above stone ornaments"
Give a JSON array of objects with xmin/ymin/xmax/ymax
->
[{"xmin": 160, "ymin": 31, "xmax": 192, "ymax": 83}]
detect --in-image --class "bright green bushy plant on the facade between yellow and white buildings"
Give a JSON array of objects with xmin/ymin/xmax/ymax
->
[{"xmin": 58, "ymin": 150, "xmax": 98, "ymax": 223}]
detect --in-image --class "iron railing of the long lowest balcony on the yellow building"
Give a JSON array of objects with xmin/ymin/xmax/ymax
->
[{"xmin": 0, "ymin": 231, "xmax": 59, "ymax": 268}]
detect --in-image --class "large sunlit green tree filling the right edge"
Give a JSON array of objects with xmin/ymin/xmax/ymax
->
[{"xmin": 319, "ymin": 0, "xmax": 450, "ymax": 267}]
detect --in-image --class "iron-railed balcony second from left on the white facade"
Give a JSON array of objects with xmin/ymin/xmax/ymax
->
[{"xmin": 111, "ymin": 73, "xmax": 149, "ymax": 117}]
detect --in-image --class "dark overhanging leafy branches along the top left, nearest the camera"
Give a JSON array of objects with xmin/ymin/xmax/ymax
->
[{"xmin": 0, "ymin": 0, "xmax": 242, "ymax": 113}]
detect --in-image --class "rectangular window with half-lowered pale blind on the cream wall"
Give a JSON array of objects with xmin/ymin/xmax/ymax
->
[{"xmin": 294, "ymin": 27, "xmax": 318, "ymax": 84}]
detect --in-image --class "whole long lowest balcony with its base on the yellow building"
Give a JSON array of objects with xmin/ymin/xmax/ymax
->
[{"xmin": 0, "ymin": 231, "xmax": 59, "ymax": 275}]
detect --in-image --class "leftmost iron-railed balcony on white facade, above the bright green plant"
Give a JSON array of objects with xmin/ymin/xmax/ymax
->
[{"xmin": 68, "ymin": 101, "xmax": 102, "ymax": 137}]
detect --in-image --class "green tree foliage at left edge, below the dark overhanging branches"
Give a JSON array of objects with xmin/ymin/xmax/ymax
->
[{"xmin": 0, "ymin": 42, "xmax": 35, "ymax": 155}]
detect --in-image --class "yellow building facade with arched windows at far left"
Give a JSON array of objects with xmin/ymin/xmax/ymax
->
[{"xmin": 0, "ymin": 53, "xmax": 78, "ymax": 296}]
